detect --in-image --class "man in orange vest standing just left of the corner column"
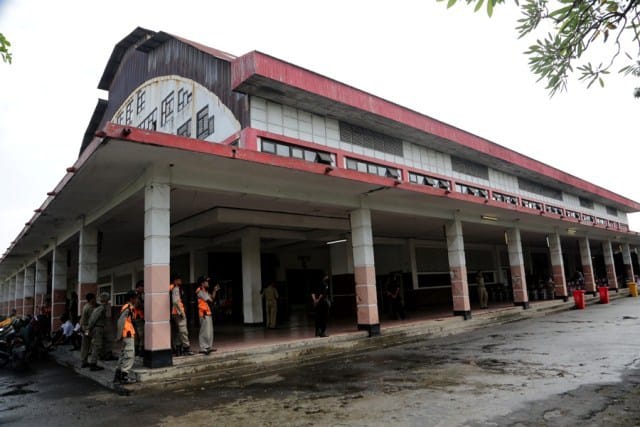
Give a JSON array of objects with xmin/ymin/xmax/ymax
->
[{"xmin": 113, "ymin": 291, "xmax": 138, "ymax": 384}]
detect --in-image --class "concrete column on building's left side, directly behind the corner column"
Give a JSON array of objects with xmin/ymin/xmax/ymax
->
[{"xmin": 76, "ymin": 226, "xmax": 98, "ymax": 316}]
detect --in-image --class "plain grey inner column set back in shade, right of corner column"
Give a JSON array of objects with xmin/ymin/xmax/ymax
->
[{"xmin": 241, "ymin": 228, "xmax": 263, "ymax": 325}]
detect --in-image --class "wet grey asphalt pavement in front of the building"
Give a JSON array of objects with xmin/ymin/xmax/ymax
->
[{"xmin": 0, "ymin": 298, "xmax": 640, "ymax": 427}]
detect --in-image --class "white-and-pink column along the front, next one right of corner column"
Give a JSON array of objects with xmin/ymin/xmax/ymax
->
[{"xmin": 350, "ymin": 209, "xmax": 380, "ymax": 336}]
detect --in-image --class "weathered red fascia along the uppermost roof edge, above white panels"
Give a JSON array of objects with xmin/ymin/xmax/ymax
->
[{"xmin": 231, "ymin": 51, "xmax": 640, "ymax": 211}]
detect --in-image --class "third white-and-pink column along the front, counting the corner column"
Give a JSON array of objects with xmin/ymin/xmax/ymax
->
[{"xmin": 445, "ymin": 219, "xmax": 471, "ymax": 320}]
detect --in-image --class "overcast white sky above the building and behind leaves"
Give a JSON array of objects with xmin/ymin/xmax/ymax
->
[{"xmin": 0, "ymin": 0, "xmax": 640, "ymax": 253}]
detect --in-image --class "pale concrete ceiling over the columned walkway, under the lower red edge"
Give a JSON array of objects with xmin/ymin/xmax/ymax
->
[{"xmin": 0, "ymin": 135, "xmax": 638, "ymax": 279}]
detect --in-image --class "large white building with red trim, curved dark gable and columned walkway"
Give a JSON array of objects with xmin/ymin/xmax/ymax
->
[{"xmin": 0, "ymin": 28, "xmax": 640, "ymax": 367}]
